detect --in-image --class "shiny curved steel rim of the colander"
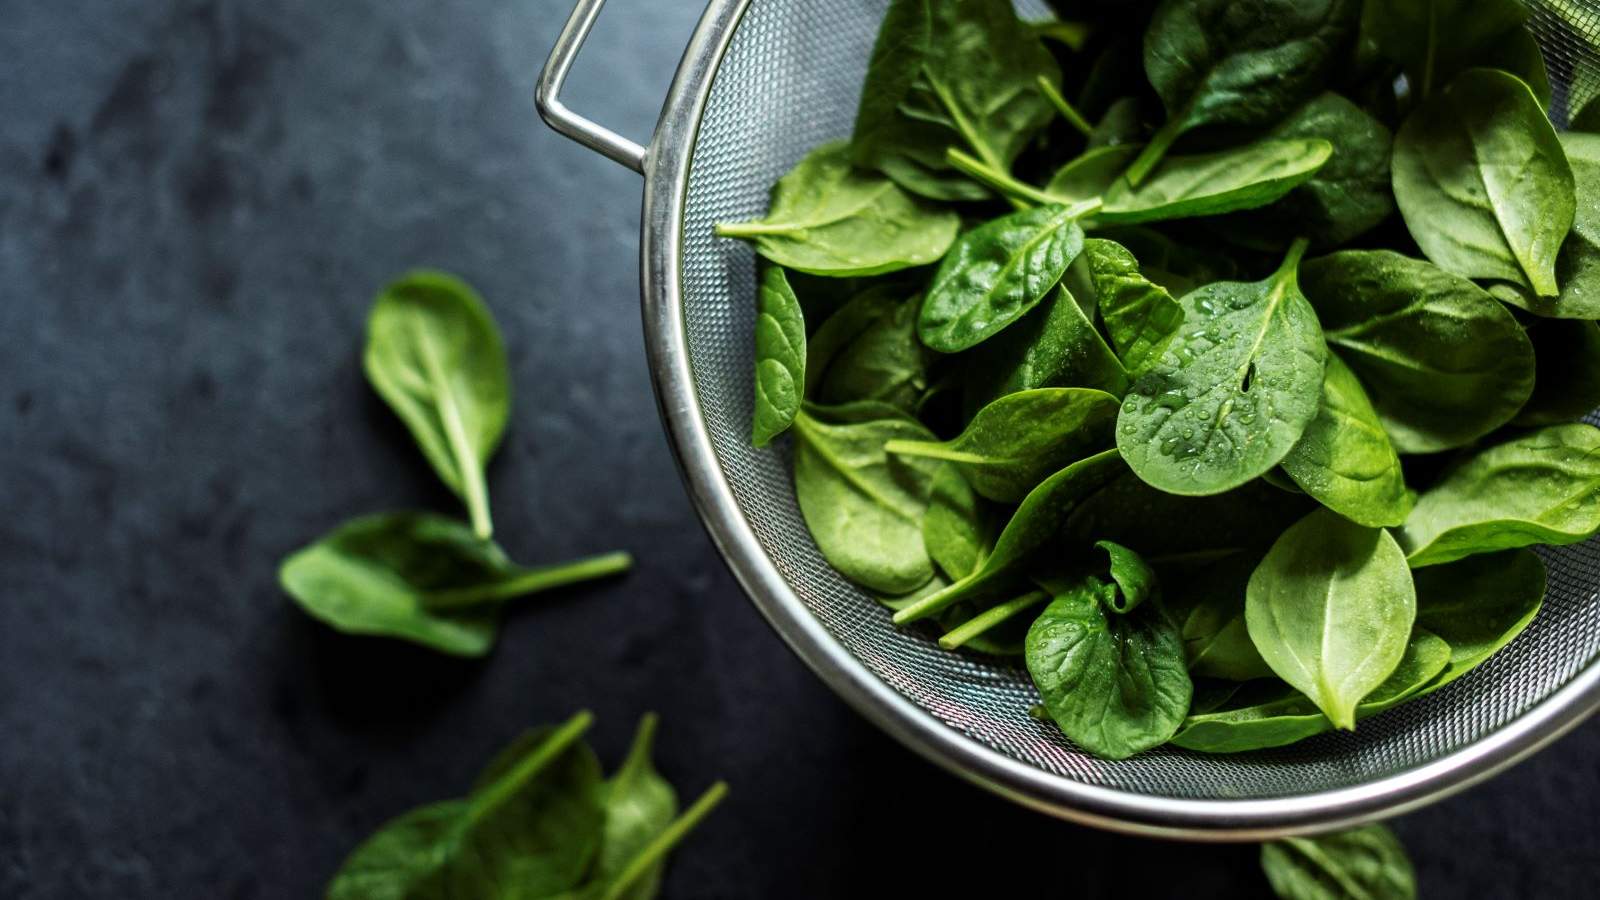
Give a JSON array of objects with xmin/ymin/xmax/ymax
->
[{"xmin": 640, "ymin": 0, "xmax": 1600, "ymax": 841}]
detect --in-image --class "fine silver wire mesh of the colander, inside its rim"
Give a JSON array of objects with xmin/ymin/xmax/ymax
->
[{"xmin": 682, "ymin": 0, "xmax": 1600, "ymax": 799}]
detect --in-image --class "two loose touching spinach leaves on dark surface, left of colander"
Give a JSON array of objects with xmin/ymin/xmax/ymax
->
[{"xmin": 278, "ymin": 271, "xmax": 634, "ymax": 657}]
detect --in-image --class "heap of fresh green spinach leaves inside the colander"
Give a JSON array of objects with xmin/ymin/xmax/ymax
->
[{"xmin": 718, "ymin": 0, "xmax": 1600, "ymax": 755}]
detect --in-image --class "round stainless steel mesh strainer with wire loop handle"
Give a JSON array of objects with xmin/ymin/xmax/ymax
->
[{"xmin": 538, "ymin": 0, "xmax": 1600, "ymax": 839}]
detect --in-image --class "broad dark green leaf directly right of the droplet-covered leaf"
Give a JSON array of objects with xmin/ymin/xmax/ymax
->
[{"xmin": 1301, "ymin": 250, "xmax": 1533, "ymax": 453}]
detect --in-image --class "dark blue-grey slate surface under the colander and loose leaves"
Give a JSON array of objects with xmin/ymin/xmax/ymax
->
[{"xmin": 0, "ymin": 0, "xmax": 1600, "ymax": 898}]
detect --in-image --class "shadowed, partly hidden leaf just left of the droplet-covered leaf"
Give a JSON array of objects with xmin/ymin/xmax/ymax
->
[{"xmin": 966, "ymin": 287, "xmax": 1128, "ymax": 412}]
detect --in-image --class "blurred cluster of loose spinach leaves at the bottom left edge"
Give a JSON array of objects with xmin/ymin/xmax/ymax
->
[{"xmin": 326, "ymin": 713, "xmax": 726, "ymax": 900}]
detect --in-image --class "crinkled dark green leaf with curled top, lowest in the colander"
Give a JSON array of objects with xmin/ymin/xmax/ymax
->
[{"xmin": 1026, "ymin": 575, "xmax": 1194, "ymax": 759}]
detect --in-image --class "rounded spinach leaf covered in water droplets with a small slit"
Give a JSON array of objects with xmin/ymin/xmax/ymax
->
[{"xmin": 1117, "ymin": 242, "xmax": 1326, "ymax": 495}]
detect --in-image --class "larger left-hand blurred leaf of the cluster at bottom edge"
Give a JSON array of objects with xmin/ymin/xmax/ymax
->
[{"xmin": 326, "ymin": 713, "xmax": 603, "ymax": 900}]
